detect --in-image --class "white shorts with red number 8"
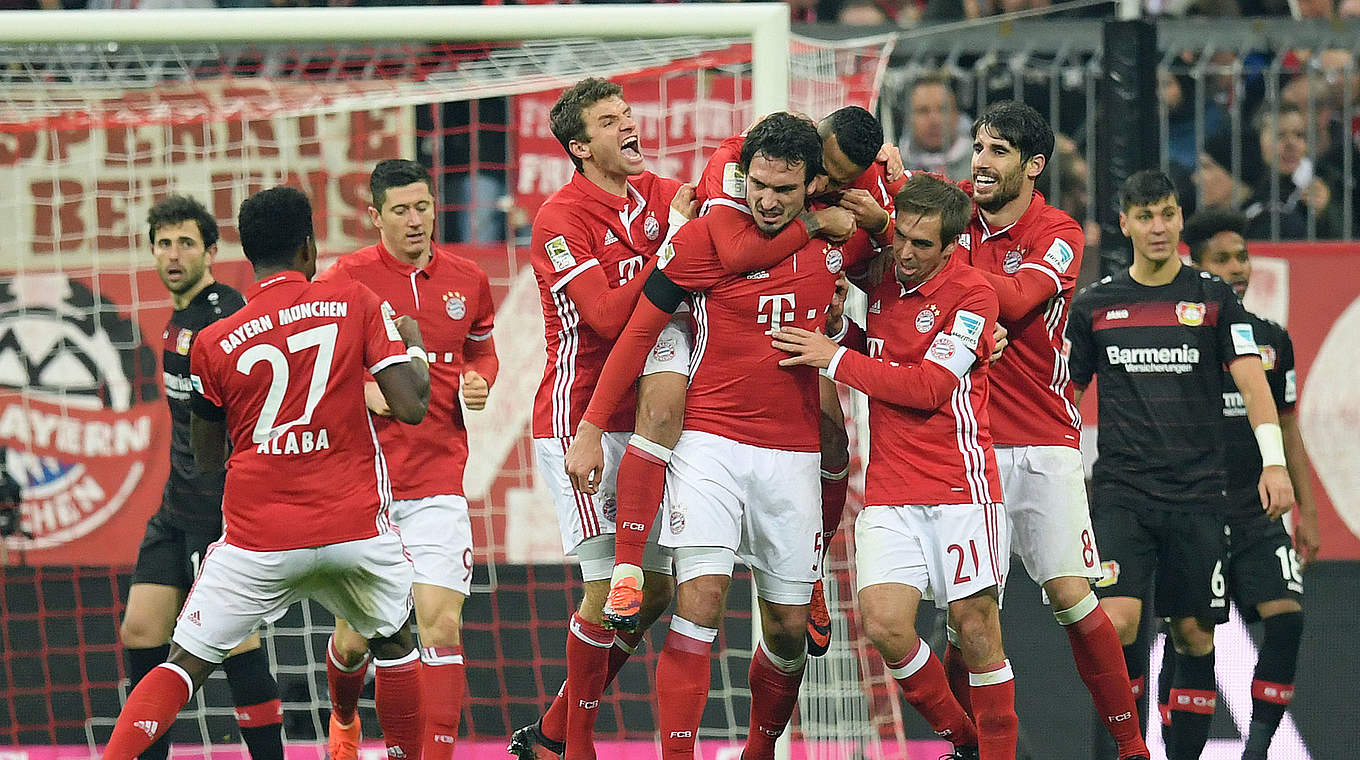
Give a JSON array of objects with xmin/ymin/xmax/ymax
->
[{"xmin": 996, "ymin": 446, "xmax": 1100, "ymax": 583}]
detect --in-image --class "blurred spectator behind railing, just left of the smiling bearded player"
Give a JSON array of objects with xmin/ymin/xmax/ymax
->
[{"xmin": 899, "ymin": 72, "xmax": 972, "ymax": 179}]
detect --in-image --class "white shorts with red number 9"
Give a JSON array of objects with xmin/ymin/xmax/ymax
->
[{"xmin": 390, "ymin": 494, "xmax": 472, "ymax": 595}]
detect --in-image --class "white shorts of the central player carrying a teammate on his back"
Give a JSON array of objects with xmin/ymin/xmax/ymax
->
[{"xmin": 661, "ymin": 430, "xmax": 821, "ymax": 604}]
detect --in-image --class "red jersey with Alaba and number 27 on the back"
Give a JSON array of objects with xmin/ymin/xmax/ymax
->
[{"xmin": 189, "ymin": 272, "xmax": 411, "ymax": 552}]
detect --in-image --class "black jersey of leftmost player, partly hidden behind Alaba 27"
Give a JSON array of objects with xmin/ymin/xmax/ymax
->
[{"xmin": 160, "ymin": 283, "xmax": 246, "ymax": 532}]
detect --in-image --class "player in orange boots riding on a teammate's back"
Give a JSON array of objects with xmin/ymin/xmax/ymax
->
[{"xmin": 598, "ymin": 106, "xmax": 892, "ymax": 657}]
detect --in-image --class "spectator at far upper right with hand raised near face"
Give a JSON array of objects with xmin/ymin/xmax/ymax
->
[{"xmin": 1244, "ymin": 103, "xmax": 1341, "ymax": 241}]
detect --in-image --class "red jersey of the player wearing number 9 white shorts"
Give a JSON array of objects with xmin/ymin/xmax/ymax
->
[{"xmin": 317, "ymin": 242, "xmax": 495, "ymax": 499}]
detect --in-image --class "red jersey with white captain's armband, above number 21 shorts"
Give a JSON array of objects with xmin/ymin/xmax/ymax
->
[{"xmin": 828, "ymin": 256, "xmax": 1001, "ymax": 506}]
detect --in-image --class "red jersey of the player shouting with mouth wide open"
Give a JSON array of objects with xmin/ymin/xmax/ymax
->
[{"xmin": 529, "ymin": 171, "xmax": 680, "ymax": 438}]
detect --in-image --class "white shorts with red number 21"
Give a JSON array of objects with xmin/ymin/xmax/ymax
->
[{"xmin": 854, "ymin": 504, "xmax": 1009, "ymax": 609}]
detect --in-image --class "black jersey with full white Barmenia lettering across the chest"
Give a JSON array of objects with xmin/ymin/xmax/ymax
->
[{"xmin": 1068, "ymin": 266, "xmax": 1258, "ymax": 510}]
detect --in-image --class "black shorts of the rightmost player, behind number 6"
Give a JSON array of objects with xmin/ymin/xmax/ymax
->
[{"xmin": 1227, "ymin": 502, "xmax": 1303, "ymax": 623}]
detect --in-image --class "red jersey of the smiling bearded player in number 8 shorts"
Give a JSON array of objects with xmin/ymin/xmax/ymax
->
[{"xmin": 956, "ymin": 192, "xmax": 1085, "ymax": 449}]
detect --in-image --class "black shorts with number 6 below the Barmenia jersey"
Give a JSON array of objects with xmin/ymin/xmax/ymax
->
[{"xmin": 1091, "ymin": 499, "xmax": 1228, "ymax": 624}]
